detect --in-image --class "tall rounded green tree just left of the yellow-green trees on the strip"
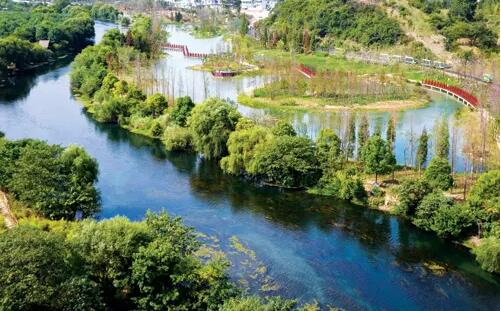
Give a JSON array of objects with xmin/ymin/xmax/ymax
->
[{"xmin": 188, "ymin": 98, "xmax": 241, "ymax": 159}]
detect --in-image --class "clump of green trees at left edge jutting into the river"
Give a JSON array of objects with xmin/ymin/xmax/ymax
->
[{"xmin": 0, "ymin": 138, "xmax": 100, "ymax": 219}]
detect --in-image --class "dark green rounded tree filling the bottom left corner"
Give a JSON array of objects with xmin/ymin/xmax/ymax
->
[{"xmin": 0, "ymin": 225, "xmax": 103, "ymax": 310}]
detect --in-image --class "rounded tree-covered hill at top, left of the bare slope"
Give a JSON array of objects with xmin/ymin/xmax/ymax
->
[{"xmin": 257, "ymin": 0, "xmax": 403, "ymax": 52}]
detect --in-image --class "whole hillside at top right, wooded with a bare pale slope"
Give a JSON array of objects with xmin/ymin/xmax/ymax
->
[{"xmin": 257, "ymin": 0, "xmax": 499, "ymax": 62}]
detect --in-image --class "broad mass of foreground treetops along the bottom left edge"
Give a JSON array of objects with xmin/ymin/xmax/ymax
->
[{"xmin": 0, "ymin": 213, "xmax": 237, "ymax": 310}]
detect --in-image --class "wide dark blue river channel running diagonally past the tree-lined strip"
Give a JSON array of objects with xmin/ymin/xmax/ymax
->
[{"xmin": 0, "ymin": 24, "xmax": 499, "ymax": 310}]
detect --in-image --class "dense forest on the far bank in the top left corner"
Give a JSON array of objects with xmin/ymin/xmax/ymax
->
[{"xmin": 0, "ymin": 0, "xmax": 121, "ymax": 73}]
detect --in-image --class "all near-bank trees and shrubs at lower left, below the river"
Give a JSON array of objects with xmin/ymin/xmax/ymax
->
[{"xmin": 0, "ymin": 137, "xmax": 324, "ymax": 311}]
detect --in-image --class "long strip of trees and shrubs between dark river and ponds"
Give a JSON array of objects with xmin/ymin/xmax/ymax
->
[{"xmin": 71, "ymin": 13, "xmax": 499, "ymax": 271}]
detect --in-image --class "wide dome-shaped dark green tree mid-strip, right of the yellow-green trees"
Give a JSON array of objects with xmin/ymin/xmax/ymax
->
[{"xmin": 249, "ymin": 136, "xmax": 321, "ymax": 188}]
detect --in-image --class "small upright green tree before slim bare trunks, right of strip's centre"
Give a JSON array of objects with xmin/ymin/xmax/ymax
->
[{"xmin": 361, "ymin": 135, "xmax": 395, "ymax": 182}]
